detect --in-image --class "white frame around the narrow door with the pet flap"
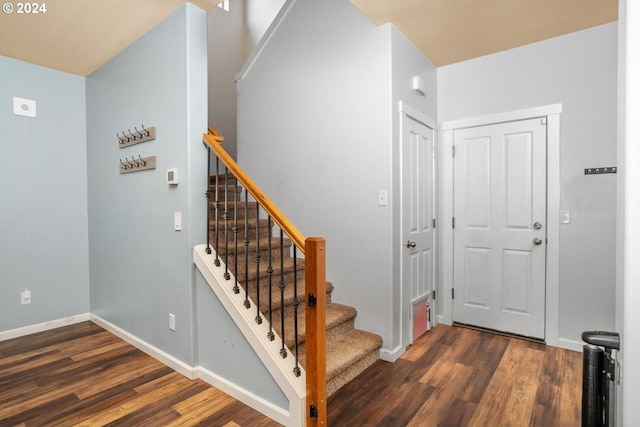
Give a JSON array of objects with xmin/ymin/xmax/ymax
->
[{"xmin": 394, "ymin": 101, "xmax": 440, "ymax": 352}]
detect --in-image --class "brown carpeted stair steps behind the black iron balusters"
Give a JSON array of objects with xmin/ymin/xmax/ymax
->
[{"xmin": 209, "ymin": 175, "xmax": 382, "ymax": 396}]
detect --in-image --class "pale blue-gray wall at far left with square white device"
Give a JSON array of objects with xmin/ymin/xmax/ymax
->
[{"xmin": 0, "ymin": 57, "xmax": 89, "ymax": 332}]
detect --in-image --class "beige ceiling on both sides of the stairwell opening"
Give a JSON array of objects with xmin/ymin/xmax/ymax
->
[{"xmin": 0, "ymin": 0, "xmax": 618, "ymax": 76}]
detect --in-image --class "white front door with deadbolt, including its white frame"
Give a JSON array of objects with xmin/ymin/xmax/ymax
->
[{"xmin": 436, "ymin": 104, "xmax": 562, "ymax": 346}]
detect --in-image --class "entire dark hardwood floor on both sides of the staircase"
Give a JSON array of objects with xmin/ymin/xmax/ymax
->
[{"xmin": 0, "ymin": 322, "xmax": 582, "ymax": 427}]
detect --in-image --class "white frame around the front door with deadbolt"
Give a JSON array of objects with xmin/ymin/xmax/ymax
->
[{"xmin": 436, "ymin": 104, "xmax": 562, "ymax": 347}]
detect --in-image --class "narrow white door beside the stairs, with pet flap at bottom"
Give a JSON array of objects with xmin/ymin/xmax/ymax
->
[{"xmin": 400, "ymin": 114, "xmax": 435, "ymax": 344}]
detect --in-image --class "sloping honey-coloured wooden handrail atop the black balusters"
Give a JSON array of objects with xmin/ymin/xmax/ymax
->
[{"xmin": 202, "ymin": 132, "xmax": 305, "ymax": 254}]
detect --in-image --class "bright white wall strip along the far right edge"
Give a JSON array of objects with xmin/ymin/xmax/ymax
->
[{"xmin": 616, "ymin": 0, "xmax": 640, "ymax": 426}]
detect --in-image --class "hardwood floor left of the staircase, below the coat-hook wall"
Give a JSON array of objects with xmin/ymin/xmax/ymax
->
[{"xmin": 0, "ymin": 322, "xmax": 279, "ymax": 427}]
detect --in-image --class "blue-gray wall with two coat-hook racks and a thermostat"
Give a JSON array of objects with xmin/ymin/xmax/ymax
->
[{"xmin": 87, "ymin": 4, "xmax": 206, "ymax": 365}]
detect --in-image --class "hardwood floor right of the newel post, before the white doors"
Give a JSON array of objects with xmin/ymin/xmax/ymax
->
[{"xmin": 328, "ymin": 325, "xmax": 582, "ymax": 427}]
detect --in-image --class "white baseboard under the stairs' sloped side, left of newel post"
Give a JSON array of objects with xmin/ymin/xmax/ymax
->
[{"xmin": 194, "ymin": 366, "xmax": 291, "ymax": 425}]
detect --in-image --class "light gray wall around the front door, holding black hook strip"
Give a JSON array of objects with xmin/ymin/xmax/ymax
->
[{"xmin": 438, "ymin": 23, "xmax": 617, "ymax": 342}]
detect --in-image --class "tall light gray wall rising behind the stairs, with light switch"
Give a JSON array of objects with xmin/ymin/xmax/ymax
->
[{"xmin": 238, "ymin": 0, "xmax": 436, "ymax": 353}]
